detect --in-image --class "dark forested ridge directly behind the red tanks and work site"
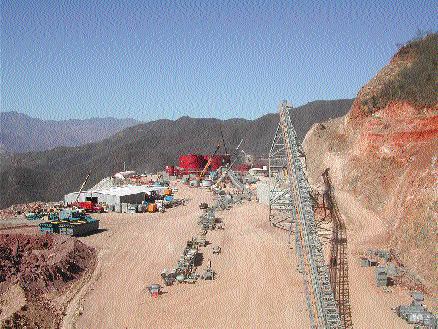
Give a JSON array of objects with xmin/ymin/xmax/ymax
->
[{"xmin": 0, "ymin": 99, "xmax": 353, "ymax": 208}]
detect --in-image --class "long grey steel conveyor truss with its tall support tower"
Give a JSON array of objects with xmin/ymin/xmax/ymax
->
[{"xmin": 269, "ymin": 101, "xmax": 343, "ymax": 328}]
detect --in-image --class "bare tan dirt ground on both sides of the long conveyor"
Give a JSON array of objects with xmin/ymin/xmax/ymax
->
[{"xmin": 54, "ymin": 184, "xmax": 410, "ymax": 329}]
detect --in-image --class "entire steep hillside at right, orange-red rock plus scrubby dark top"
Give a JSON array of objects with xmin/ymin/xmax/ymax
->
[{"xmin": 304, "ymin": 34, "xmax": 438, "ymax": 289}]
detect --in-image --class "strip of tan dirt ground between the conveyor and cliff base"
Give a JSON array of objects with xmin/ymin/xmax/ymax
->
[{"xmin": 336, "ymin": 191, "xmax": 432, "ymax": 329}]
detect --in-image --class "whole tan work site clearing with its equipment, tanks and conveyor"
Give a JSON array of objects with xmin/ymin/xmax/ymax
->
[{"xmin": 0, "ymin": 101, "xmax": 437, "ymax": 329}]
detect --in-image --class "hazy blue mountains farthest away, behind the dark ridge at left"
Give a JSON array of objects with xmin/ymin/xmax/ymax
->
[{"xmin": 0, "ymin": 112, "xmax": 140, "ymax": 153}]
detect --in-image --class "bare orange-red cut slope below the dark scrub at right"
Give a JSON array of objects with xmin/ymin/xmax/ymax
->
[{"xmin": 304, "ymin": 103, "xmax": 438, "ymax": 291}]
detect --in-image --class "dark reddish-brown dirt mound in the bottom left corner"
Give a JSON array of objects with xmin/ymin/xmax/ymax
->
[{"xmin": 0, "ymin": 234, "xmax": 95, "ymax": 328}]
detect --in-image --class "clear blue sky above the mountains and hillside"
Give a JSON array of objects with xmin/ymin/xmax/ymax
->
[{"xmin": 1, "ymin": 0, "xmax": 438, "ymax": 121}]
